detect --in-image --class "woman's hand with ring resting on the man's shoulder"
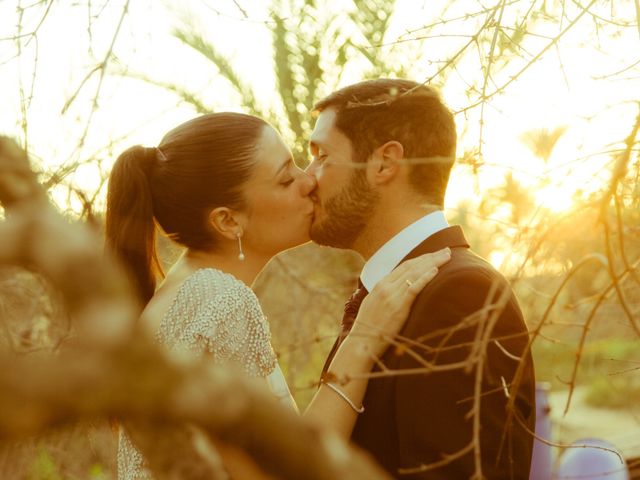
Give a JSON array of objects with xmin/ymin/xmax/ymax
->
[{"xmin": 345, "ymin": 248, "xmax": 451, "ymax": 357}]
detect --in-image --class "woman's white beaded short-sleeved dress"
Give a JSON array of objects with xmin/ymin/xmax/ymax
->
[{"xmin": 118, "ymin": 268, "xmax": 296, "ymax": 480}]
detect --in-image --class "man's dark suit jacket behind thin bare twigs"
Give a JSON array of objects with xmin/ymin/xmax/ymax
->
[{"xmin": 338, "ymin": 227, "xmax": 535, "ymax": 480}]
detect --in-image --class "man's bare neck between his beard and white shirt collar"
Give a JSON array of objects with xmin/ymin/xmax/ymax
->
[{"xmin": 353, "ymin": 205, "xmax": 441, "ymax": 261}]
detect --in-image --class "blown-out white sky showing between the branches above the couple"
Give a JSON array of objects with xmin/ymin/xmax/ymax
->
[{"xmin": 0, "ymin": 0, "xmax": 640, "ymax": 258}]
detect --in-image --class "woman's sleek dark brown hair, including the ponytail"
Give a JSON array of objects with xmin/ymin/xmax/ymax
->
[{"xmin": 106, "ymin": 113, "xmax": 268, "ymax": 303}]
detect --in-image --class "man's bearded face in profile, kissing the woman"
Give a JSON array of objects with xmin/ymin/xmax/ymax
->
[{"xmin": 307, "ymin": 108, "xmax": 378, "ymax": 248}]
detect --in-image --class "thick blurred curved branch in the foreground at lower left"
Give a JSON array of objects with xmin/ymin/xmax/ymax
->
[{"xmin": 0, "ymin": 137, "xmax": 388, "ymax": 480}]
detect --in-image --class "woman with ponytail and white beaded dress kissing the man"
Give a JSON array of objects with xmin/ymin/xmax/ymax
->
[{"xmin": 106, "ymin": 113, "xmax": 449, "ymax": 479}]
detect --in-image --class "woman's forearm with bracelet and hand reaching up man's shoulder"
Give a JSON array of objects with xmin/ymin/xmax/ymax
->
[{"xmin": 304, "ymin": 248, "xmax": 451, "ymax": 439}]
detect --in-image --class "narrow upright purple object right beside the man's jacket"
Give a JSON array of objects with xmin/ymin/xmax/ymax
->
[{"xmin": 529, "ymin": 382, "xmax": 553, "ymax": 480}]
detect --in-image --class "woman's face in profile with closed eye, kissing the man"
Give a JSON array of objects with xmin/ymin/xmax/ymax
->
[{"xmin": 242, "ymin": 126, "xmax": 316, "ymax": 256}]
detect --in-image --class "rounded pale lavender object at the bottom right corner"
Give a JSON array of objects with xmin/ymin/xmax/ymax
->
[{"xmin": 556, "ymin": 438, "xmax": 629, "ymax": 480}]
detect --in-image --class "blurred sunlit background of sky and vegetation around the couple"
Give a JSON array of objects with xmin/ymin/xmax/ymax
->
[{"xmin": 0, "ymin": 0, "xmax": 640, "ymax": 479}]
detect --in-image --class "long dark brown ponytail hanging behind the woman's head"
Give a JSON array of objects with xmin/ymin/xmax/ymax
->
[{"xmin": 105, "ymin": 145, "xmax": 162, "ymax": 304}]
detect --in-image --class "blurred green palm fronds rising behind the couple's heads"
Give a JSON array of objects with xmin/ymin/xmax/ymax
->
[{"xmin": 169, "ymin": 0, "xmax": 404, "ymax": 166}]
